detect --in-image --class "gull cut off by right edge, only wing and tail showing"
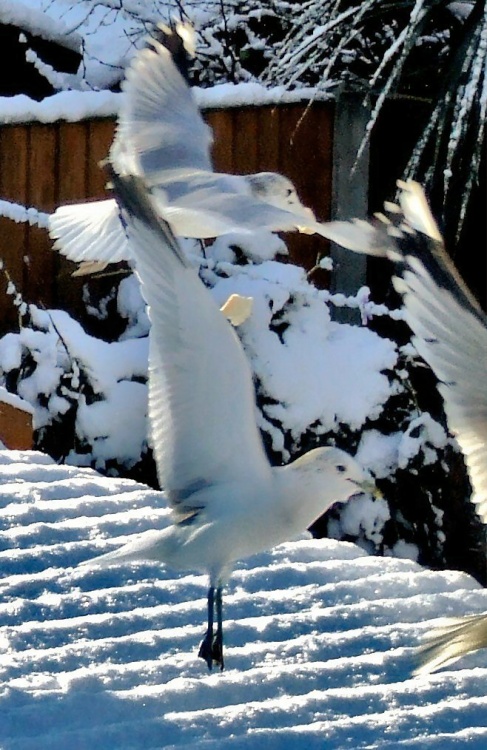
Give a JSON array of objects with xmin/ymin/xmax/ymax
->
[{"xmin": 328, "ymin": 181, "xmax": 487, "ymax": 673}]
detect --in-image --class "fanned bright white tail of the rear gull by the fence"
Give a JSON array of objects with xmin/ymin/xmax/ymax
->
[{"xmin": 49, "ymin": 199, "xmax": 130, "ymax": 270}]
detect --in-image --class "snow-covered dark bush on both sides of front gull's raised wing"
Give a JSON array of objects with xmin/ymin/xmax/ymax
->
[{"xmin": 0, "ymin": 233, "xmax": 480, "ymax": 573}]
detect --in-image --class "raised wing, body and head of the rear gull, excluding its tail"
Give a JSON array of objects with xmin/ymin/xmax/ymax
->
[{"xmin": 117, "ymin": 30, "xmax": 336, "ymax": 238}]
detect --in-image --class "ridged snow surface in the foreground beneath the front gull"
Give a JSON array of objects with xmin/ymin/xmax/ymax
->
[{"xmin": 0, "ymin": 451, "xmax": 487, "ymax": 750}]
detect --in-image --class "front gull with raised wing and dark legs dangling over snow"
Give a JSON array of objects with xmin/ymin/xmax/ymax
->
[{"xmin": 90, "ymin": 163, "xmax": 375, "ymax": 669}]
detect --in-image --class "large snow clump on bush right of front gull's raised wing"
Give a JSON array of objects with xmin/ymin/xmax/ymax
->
[{"xmin": 207, "ymin": 258, "xmax": 397, "ymax": 446}]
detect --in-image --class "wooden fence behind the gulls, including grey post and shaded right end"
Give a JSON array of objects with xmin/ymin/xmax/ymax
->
[{"xmin": 0, "ymin": 97, "xmax": 487, "ymax": 334}]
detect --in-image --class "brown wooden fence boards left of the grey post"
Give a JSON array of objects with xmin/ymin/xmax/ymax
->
[{"xmin": 0, "ymin": 103, "xmax": 334, "ymax": 332}]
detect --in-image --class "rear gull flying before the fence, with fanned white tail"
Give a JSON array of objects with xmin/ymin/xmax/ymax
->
[{"xmin": 49, "ymin": 26, "xmax": 334, "ymax": 272}]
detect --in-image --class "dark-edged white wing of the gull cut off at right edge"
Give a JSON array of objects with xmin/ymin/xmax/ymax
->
[{"xmin": 395, "ymin": 229, "xmax": 487, "ymax": 521}]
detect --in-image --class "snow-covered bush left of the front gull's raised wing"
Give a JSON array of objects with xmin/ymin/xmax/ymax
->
[{"xmin": 0, "ymin": 278, "xmax": 152, "ymax": 482}]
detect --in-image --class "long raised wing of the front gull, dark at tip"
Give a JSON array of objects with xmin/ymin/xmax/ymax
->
[{"xmin": 108, "ymin": 173, "xmax": 270, "ymax": 504}]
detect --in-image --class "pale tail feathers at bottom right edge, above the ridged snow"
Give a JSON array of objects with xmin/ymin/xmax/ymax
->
[{"xmin": 414, "ymin": 613, "xmax": 487, "ymax": 675}]
